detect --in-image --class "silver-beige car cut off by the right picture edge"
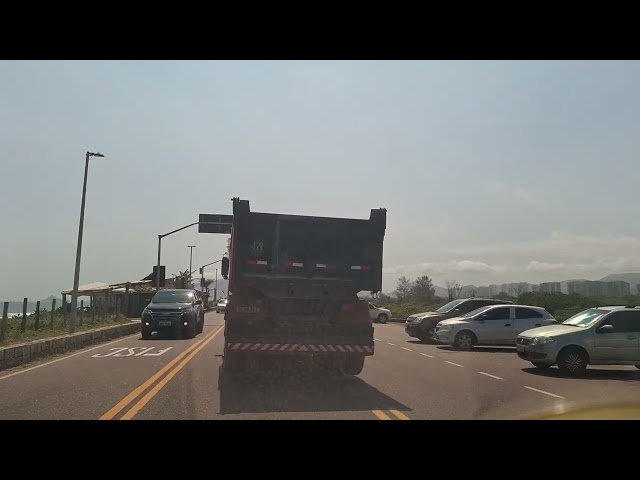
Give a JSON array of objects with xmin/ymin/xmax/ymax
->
[{"xmin": 516, "ymin": 305, "xmax": 640, "ymax": 375}]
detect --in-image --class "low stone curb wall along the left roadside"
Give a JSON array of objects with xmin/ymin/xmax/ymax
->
[{"xmin": 0, "ymin": 321, "xmax": 140, "ymax": 371}]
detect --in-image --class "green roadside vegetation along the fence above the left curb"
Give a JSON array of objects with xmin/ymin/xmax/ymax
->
[{"xmin": 0, "ymin": 309, "xmax": 131, "ymax": 347}]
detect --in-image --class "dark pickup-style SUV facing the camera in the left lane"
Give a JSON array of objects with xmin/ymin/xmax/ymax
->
[{"xmin": 140, "ymin": 289, "xmax": 204, "ymax": 339}]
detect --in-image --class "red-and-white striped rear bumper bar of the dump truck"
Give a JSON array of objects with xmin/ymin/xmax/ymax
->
[{"xmin": 225, "ymin": 342, "xmax": 375, "ymax": 356}]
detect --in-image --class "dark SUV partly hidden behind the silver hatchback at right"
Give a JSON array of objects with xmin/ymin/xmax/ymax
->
[{"xmin": 404, "ymin": 298, "xmax": 513, "ymax": 343}]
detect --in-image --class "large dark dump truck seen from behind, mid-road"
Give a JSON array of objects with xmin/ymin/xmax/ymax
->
[{"xmin": 216, "ymin": 198, "xmax": 386, "ymax": 375}]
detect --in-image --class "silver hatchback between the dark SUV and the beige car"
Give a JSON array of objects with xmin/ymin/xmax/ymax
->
[{"xmin": 436, "ymin": 305, "xmax": 558, "ymax": 350}]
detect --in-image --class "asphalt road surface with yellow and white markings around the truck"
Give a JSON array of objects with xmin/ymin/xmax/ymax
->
[{"xmin": 0, "ymin": 313, "xmax": 640, "ymax": 420}]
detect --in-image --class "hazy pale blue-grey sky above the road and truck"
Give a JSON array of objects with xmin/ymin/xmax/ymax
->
[{"xmin": 0, "ymin": 61, "xmax": 640, "ymax": 300}]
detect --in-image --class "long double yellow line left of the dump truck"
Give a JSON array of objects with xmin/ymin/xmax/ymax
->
[{"xmin": 100, "ymin": 325, "xmax": 224, "ymax": 420}]
